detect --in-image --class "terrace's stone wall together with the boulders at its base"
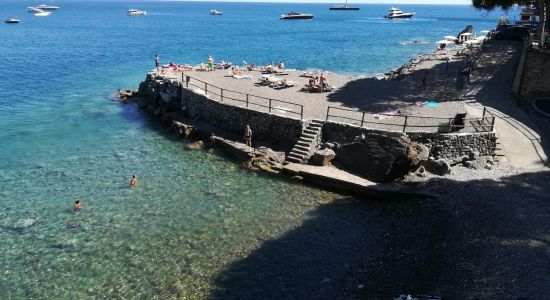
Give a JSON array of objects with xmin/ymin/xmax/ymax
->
[{"xmin": 129, "ymin": 73, "xmax": 496, "ymax": 182}]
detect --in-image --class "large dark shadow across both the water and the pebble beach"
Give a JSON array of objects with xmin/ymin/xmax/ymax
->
[{"xmin": 210, "ymin": 172, "xmax": 550, "ymax": 299}]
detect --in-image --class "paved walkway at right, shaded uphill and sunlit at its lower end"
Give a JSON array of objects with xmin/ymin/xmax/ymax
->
[{"xmin": 463, "ymin": 41, "xmax": 549, "ymax": 170}]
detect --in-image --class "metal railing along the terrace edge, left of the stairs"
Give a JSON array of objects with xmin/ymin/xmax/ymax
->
[{"xmin": 181, "ymin": 73, "xmax": 304, "ymax": 120}]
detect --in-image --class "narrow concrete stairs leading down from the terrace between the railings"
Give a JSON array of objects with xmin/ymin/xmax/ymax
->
[{"xmin": 285, "ymin": 120, "xmax": 323, "ymax": 164}]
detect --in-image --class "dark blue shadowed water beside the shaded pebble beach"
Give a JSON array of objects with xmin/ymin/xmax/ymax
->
[{"xmin": 210, "ymin": 197, "xmax": 454, "ymax": 299}]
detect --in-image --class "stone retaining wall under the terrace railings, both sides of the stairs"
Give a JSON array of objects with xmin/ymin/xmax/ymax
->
[{"xmin": 138, "ymin": 74, "xmax": 496, "ymax": 160}]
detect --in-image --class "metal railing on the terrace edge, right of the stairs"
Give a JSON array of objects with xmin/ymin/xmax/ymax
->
[{"xmin": 326, "ymin": 106, "xmax": 495, "ymax": 133}]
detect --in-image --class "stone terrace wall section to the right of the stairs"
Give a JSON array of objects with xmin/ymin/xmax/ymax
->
[{"xmin": 322, "ymin": 122, "xmax": 497, "ymax": 160}]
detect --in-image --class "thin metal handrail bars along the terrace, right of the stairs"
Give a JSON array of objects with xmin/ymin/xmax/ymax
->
[{"xmin": 326, "ymin": 106, "xmax": 496, "ymax": 132}]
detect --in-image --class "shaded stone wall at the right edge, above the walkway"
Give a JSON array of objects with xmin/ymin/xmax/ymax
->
[{"xmin": 519, "ymin": 49, "xmax": 550, "ymax": 103}]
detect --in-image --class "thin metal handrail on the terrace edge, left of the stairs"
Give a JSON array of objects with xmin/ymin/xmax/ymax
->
[{"xmin": 181, "ymin": 72, "xmax": 304, "ymax": 120}]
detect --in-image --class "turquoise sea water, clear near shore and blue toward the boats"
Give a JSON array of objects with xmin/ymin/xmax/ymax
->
[{"xmin": 0, "ymin": 0, "xmax": 508, "ymax": 299}]
